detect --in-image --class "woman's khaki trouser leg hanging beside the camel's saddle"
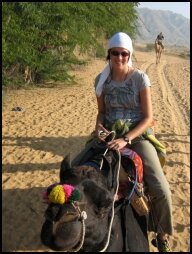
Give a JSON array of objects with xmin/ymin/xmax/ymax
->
[{"xmin": 131, "ymin": 140, "xmax": 173, "ymax": 236}]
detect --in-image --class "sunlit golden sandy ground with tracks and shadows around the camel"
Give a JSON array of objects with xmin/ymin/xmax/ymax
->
[{"xmin": 2, "ymin": 52, "xmax": 190, "ymax": 252}]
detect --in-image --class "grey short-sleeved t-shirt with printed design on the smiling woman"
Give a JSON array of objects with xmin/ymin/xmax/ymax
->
[{"xmin": 95, "ymin": 69, "xmax": 151, "ymax": 123}]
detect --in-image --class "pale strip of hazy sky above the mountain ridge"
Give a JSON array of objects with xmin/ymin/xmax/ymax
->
[{"xmin": 138, "ymin": 2, "xmax": 190, "ymax": 19}]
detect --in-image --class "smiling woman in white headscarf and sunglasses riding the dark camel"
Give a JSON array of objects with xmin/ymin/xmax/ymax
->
[{"xmin": 73, "ymin": 32, "xmax": 173, "ymax": 252}]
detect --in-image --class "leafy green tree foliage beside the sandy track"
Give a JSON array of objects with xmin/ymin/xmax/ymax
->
[{"xmin": 2, "ymin": 2, "xmax": 138, "ymax": 86}]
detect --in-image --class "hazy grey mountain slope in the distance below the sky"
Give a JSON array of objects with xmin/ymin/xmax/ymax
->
[{"xmin": 135, "ymin": 8, "xmax": 190, "ymax": 48}]
